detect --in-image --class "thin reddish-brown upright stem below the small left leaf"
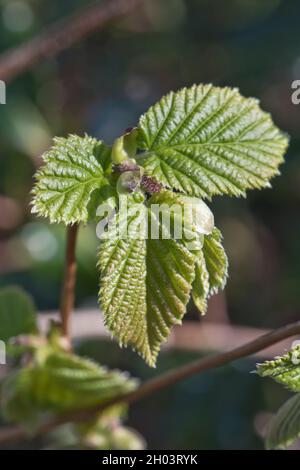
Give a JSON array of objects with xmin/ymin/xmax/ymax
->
[{"xmin": 60, "ymin": 224, "xmax": 78, "ymax": 344}]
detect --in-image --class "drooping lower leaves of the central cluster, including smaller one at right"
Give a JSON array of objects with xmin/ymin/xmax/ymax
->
[{"xmin": 98, "ymin": 191, "xmax": 227, "ymax": 366}]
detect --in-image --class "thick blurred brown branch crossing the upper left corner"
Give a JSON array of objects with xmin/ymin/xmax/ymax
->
[{"xmin": 0, "ymin": 0, "xmax": 142, "ymax": 82}]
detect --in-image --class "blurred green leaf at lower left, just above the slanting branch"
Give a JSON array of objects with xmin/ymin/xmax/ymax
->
[{"xmin": 1, "ymin": 346, "xmax": 136, "ymax": 421}]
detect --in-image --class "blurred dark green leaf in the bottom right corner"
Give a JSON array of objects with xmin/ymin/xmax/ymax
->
[{"xmin": 266, "ymin": 393, "xmax": 300, "ymax": 449}]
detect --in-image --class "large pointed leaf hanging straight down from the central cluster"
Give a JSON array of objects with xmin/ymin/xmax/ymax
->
[{"xmin": 99, "ymin": 195, "xmax": 195, "ymax": 366}]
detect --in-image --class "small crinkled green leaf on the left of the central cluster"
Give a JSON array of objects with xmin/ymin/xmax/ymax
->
[{"xmin": 32, "ymin": 135, "xmax": 111, "ymax": 224}]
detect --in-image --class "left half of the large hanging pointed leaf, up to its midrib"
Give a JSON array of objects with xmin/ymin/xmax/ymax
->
[{"xmin": 98, "ymin": 206, "xmax": 151, "ymax": 359}]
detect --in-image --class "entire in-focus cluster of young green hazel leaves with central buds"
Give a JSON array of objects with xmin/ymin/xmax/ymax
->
[{"xmin": 28, "ymin": 85, "xmax": 288, "ymax": 366}]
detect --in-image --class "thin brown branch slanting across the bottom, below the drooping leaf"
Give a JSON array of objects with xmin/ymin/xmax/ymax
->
[{"xmin": 0, "ymin": 321, "xmax": 300, "ymax": 444}]
